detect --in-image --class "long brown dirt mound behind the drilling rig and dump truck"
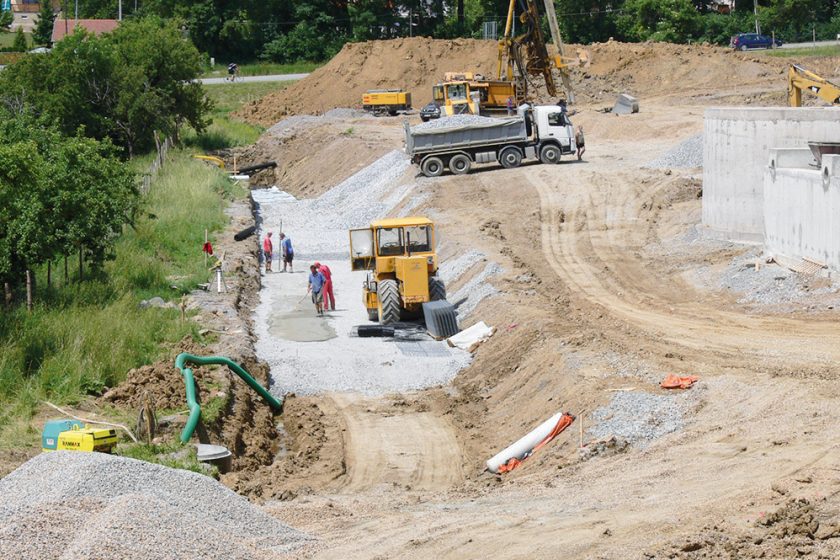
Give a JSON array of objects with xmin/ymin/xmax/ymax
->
[{"xmin": 238, "ymin": 37, "xmax": 808, "ymax": 126}]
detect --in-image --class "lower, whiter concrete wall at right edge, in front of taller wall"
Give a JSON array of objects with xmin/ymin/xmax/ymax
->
[{"xmin": 764, "ymin": 150, "xmax": 840, "ymax": 270}]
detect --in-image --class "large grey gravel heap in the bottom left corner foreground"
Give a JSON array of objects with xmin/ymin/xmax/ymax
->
[{"xmin": 0, "ymin": 451, "xmax": 310, "ymax": 560}]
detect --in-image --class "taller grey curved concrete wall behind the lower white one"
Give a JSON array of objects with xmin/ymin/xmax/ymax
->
[{"xmin": 703, "ymin": 107, "xmax": 840, "ymax": 243}]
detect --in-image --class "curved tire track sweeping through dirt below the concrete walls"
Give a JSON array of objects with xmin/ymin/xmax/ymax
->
[{"xmin": 523, "ymin": 168, "xmax": 840, "ymax": 363}]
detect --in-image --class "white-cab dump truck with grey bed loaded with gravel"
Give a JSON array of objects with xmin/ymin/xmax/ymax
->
[{"xmin": 405, "ymin": 105, "xmax": 577, "ymax": 177}]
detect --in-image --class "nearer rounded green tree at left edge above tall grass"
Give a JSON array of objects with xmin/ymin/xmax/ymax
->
[{"xmin": 0, "ymin": 113, "xmax": 138, "ymax": 306}]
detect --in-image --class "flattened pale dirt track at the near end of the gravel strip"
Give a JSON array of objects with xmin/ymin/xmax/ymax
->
[{"xmin": 329, "ymin": 393, "xmax": 464, "ymax": 492}]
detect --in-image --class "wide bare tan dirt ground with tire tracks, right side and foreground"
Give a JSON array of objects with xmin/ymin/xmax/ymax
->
[{"xmin": 253, "ymin": 101, "xmax": 840, "ymax": 558}]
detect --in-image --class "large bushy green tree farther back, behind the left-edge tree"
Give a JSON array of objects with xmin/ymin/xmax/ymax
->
[{"xmin": 0, "ymin": 18, "xmax": 211, "ymax": 156}]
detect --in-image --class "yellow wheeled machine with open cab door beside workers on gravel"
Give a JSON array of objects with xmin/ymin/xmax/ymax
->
[{"xmin": 350, "ymin": 217, "xmax": 446, "ymax": 325}]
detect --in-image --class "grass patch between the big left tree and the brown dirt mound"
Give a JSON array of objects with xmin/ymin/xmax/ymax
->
[{"xmin": 184, "ymin": 82, "xmax": 292, "ymax": 152}]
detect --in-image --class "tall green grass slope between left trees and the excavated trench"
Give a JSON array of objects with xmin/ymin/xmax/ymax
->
[{"xmin": 0, "ymin": 151, "xmax": 242, "ymax": 447}]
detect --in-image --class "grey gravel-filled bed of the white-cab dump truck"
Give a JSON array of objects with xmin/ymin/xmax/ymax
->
[{"xmin": 405, "ymin": 117, "xmax": 528, "ymax": 156}]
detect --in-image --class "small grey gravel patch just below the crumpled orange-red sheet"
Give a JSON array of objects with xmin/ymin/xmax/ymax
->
[{"xmin": 588, "ymin": 388, "xmax": 697, "ymax": 447}]
